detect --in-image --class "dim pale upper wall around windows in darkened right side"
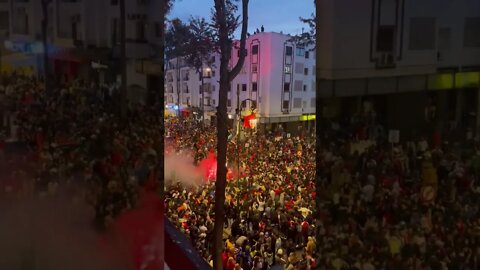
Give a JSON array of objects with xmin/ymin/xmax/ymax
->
[{"xmin": 317, "ymin": 0, "xmax": 480, "ymax": 79}]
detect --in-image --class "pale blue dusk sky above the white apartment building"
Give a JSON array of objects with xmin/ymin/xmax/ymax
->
[{"xmin": 169, "ymin": 0, "xmax": 315, "ymax": 37}]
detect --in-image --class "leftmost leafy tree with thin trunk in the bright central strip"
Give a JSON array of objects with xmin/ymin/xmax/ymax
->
[{"xmin": 165, "ymin": 18, "xmax": 190, "ymax": 116}]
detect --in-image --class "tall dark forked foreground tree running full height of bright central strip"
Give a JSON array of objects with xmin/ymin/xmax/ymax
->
[{"xmin": 212, "ymin": 0, "xmax": 249, "ymax": 270}]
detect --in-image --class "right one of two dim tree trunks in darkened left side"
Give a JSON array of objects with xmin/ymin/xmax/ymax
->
[{"xmin": 120, "ymin": 0, "xmax": 128, "ymax": 119}]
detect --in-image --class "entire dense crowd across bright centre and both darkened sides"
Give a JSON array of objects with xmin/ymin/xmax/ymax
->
[{"xmin": 0, "ymin": 72, "xmax": 480, "ymax": 270}]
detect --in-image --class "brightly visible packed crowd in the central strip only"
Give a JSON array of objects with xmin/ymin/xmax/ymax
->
[{"xmin": 165, "ymin": 117, "xmax": 315, "ymax": 270}]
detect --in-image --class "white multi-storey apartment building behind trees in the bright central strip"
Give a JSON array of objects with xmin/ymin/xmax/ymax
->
[{"xmin": 165, "ymin": 32, "xmax": 316, "ymax": 132}]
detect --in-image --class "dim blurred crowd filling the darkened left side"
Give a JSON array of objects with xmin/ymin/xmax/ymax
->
[{"xmin": 0, "ymin": 74, "xmax": 163, "ymax": 234}]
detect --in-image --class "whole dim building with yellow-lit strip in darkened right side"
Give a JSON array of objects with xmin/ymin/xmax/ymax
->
[{"xmin": 317, "ymin": 0, "xmax": 480, "ymax": 138}]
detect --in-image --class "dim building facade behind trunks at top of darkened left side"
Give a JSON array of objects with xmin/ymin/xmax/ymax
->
[{"xmin": 0, "ymin": 0, "xmax": 161, "ymax": 100}]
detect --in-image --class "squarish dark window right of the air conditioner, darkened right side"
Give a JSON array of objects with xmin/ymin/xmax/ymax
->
[{"xmin": 408, "ymin": 18, "xmax": 435, "ymax": 50}]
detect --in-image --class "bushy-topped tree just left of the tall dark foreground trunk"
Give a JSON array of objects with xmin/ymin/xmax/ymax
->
[{"xmin": 185, "ymin": 17, "xmax": 216, "ymax": 125}]
